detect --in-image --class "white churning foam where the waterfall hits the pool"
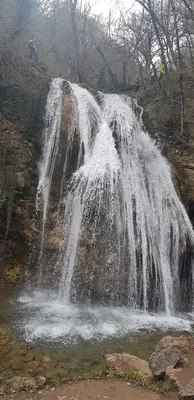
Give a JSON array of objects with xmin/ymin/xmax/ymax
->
[{"xmin": 18, "ymin": 292, "xmax": 193, "ymax": 344}]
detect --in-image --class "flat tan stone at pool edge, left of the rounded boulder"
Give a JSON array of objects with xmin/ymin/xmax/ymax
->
[{"xmin": 105, "ymin": 353, "xmax": 152, "ymax": 380}]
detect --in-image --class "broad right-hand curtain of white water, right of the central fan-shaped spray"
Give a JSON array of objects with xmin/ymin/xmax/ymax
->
[{"xmin": 103, "ymin": 95, "xmax": 193, "ymax": 313}]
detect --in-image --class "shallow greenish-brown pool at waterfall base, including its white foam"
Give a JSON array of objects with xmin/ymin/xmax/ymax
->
[{"xmin": 1, "ymin": 290, "xmax": 194, "ymax": 370}]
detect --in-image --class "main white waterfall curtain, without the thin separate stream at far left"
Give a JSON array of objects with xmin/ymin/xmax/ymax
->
[{"xmin": 55, "ymin": 85, "xmax": 193, "ymax": 313}]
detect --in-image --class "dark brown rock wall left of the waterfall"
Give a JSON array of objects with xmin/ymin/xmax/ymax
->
[{"xmin": 0, "ymin": 73, "xmax": 49, "ymax": 285}]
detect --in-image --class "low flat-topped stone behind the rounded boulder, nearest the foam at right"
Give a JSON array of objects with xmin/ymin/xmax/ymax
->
[{"xmin": 156, "ymin": 335, "xmax": 190, "ymax": 352}]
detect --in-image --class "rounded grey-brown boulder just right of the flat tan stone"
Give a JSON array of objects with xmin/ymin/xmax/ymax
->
[{"xmin": 150, "ymin": 346, "xmax": 181, "ymax": 379}]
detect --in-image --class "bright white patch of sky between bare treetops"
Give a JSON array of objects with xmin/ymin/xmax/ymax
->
[{"xmin": 87, "ymin": 0, "xmax": 140, "ymax": 17}]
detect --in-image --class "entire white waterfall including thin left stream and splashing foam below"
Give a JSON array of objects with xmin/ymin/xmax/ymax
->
[{"xmin": 17, "ymin": 80, "xmax": 194, "ymax": 337}]
